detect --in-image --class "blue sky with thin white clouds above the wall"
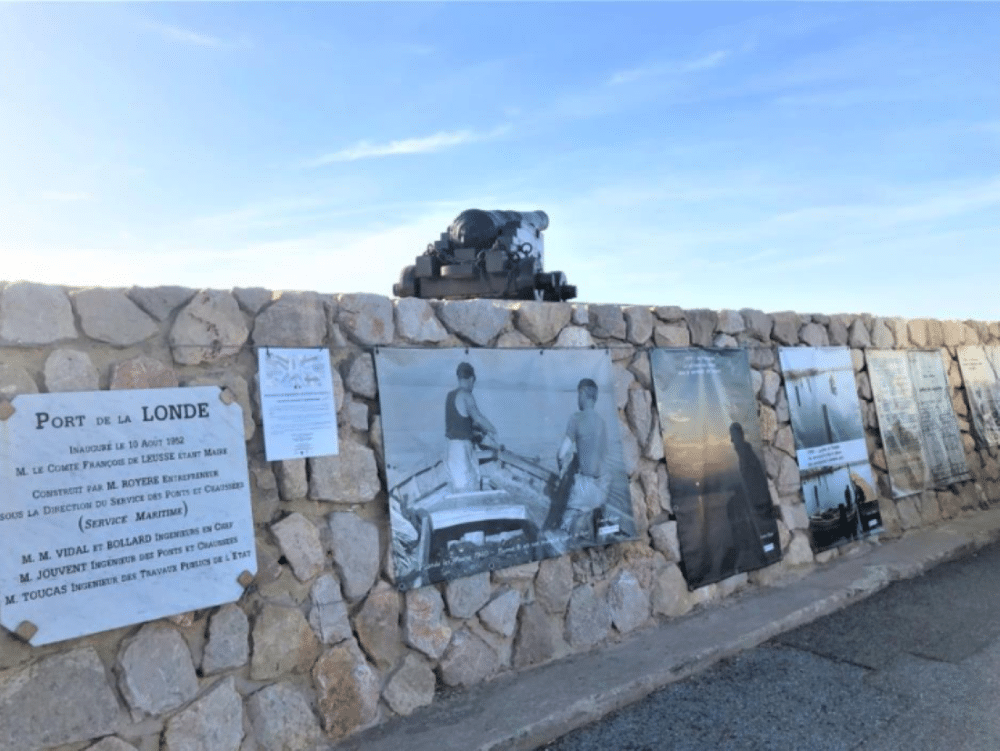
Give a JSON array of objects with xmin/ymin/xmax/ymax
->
[{"xmin": 0, "ymin": 2, "xmax": 1000, "ymax": 320}]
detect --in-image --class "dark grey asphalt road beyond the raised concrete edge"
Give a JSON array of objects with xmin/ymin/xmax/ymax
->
[{"xmin": 544, "ymin": 545, "xmax": 1000, "ymax": 751}]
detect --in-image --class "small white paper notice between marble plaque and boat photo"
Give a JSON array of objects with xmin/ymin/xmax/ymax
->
[{"xmin": 257, "ymin": 347, "xmax": 339, "ymax": 461}]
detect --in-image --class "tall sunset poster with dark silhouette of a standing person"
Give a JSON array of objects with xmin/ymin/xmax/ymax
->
[{"xmin": 650, "ymin": 349, "xmax": 781, "ymax": 589}]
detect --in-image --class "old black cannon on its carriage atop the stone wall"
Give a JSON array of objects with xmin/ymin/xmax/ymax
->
[{"xmin": 392, "ymin": 209, "xmax": 576, "ymax": 302}]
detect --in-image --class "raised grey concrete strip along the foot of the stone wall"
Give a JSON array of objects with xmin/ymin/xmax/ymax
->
[{"xmin": 340, "ymin": 509, "xmax": 1000, "ymax": 751}]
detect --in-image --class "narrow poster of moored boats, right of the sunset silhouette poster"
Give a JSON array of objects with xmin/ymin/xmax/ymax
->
[{"xmin": 778, "ymin": 347, "xmax": 882, "ymax": 552}]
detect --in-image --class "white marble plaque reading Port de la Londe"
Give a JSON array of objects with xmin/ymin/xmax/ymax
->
[{"xmin": 0, "ymin": 386, "xmax": 257, "ymax": 645}]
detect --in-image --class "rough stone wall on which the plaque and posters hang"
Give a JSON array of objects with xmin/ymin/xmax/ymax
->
[{"xmin": 0, "ymin": 282, "xmax": 1000, "ymax": 751}]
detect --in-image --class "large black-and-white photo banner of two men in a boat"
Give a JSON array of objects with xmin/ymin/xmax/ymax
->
[{"xmin": 375, "ymin": 348, "xmax": 635, "ymax": 590}]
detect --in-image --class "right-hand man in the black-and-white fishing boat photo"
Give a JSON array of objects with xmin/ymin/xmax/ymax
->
[{"xmin": 557, "ymin": 378, "xmax": 610, "ymax": 539}]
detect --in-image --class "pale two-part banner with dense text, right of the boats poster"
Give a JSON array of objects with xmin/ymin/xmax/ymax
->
[{"xmin": 865, "ymin": 349, "xmax": 969, "ymax": 498}]
